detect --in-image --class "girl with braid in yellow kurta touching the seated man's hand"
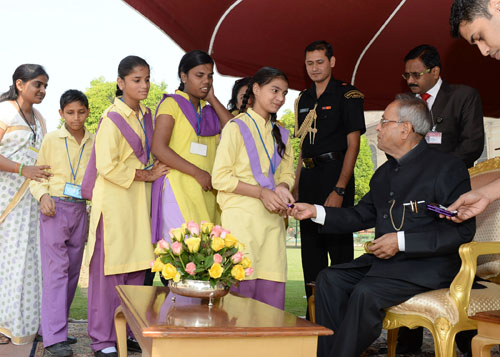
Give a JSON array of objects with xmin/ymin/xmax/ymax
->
[{"xmin": 212, "ymin": 67, "xmax": 294, "ymax": 309}]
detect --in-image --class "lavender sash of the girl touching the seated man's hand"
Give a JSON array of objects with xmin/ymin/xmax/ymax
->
[{"xmin": 232, "ymin": 119, "xmax": 288, "ymax": 190}]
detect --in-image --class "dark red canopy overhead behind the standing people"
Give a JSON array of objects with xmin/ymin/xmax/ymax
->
[{"xmin": 125, "ymin": 0, "xmax": 500, "ymax": 117}]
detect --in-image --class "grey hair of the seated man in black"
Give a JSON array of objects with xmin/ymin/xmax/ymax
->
[{"xmin": 396, "ymin": 94, "xmax": 432, "ymax": 136}]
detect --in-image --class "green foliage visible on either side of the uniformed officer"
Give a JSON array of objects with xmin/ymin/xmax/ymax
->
[{"xmin": 279, "ymin": 109, "xmax": 373, "ymax": 203}]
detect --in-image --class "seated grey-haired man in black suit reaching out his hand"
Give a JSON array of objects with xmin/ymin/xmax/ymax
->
[{"xmin": 289, "ymin": 95, "xmax": 475, "ymax": 357}]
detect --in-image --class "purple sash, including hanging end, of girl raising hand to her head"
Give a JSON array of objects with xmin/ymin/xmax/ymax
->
[{"xmin": 151, "ymin": 94, "xmax": 221, "ymax": 243}]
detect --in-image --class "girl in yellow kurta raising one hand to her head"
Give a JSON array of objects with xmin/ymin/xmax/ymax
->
[{"xmin": 152, "ymin": 50, "xmax": 232, "ymax": 242}]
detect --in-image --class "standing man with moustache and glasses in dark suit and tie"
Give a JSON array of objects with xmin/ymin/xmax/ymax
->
[{"xmin": 403, "ymin": 45, "xmax": 484, "ymax": 167}]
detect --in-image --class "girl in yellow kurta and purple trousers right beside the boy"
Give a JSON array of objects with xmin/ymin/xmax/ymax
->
[{"xmin": 86, "ymin": 56, "xmax": 167, "ymax": 356}]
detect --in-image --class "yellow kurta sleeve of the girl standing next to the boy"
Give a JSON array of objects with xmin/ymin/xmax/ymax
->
[{"xmin": 95, "ymin": 116, "xmax": 135, "ymax": 188}]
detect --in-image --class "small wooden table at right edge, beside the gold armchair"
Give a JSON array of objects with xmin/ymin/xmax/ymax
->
[{"xmin": 471, "ymin": 310, "xmax": 500, "ymax": 357}]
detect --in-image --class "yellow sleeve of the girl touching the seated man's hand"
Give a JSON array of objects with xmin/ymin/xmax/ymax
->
[{"xmin": 212, "ymin": 123, "xmax": 243, "ymax": 192}]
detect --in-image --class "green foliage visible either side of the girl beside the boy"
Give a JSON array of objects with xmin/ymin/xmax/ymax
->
[{"xmin": 61, "ymin": 77, "xmax": 167, "ymax": 133}]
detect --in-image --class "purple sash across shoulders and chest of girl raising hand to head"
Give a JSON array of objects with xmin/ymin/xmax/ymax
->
[{"xmin": 155, "ymin": 94, "xmax": 221, "ymax": 136}]
